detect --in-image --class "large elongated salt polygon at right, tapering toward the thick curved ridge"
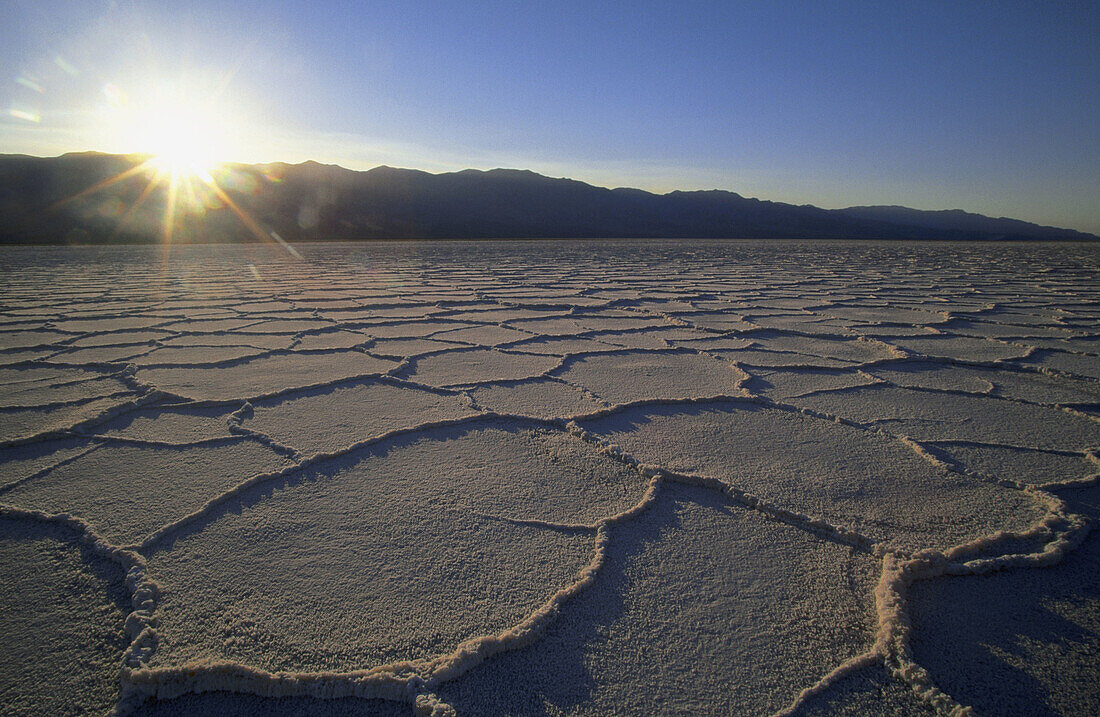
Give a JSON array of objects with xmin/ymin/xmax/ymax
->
[{"xmin": 582, "ymin": 401, "xmax": 1045, "ymax": 550}]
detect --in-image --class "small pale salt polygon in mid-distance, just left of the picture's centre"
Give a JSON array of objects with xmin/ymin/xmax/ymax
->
[{"xmin": 406, "ymin": 349, "xmax": 560, "ymax": 386}]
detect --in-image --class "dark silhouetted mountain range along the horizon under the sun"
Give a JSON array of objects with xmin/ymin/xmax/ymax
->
[{"xmin": 0, "ymin": 153, "xmax": 1098, "ymax": 244}]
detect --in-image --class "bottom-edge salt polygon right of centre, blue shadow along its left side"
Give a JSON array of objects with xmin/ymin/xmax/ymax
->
[{"xmin": 438, "ymin": 485, "xmax": 878, "ymax": 715}]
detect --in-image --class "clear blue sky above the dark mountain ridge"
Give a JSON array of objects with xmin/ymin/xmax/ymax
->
[{"xmin": 0, "ymin": 0, "xmax": 1100, "ymax": 232}]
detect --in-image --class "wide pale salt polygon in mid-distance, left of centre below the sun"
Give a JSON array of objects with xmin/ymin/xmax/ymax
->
[{"xmin": 135, "ymin": 351, "xmax": 397, "ymax": 400}]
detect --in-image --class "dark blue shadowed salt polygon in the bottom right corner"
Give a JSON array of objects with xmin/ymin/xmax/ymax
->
[{"xmin": 910, "ymin": 488, "xmax": 1100, "ymax": 716}]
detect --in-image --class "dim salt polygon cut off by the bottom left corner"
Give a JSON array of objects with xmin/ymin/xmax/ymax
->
[{"xmin": 0, "ymin": 517, "xmax": 131, "ymax": 717}]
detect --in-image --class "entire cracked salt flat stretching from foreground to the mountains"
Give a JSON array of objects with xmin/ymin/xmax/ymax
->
[{"xmin": 0, "ymin": 241, "xmax": 1100, "ymax": 716}]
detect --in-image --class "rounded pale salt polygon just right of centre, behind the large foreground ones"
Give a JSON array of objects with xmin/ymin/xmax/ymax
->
[{"xmin": 558, "ymin": 352, "xmax": 746, "ymax": 404}]
